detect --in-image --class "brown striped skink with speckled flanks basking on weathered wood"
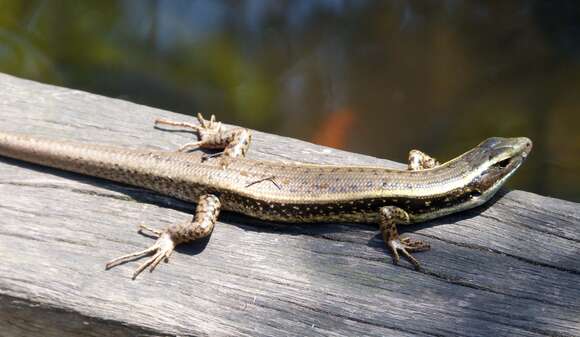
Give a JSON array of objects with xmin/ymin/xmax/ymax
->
[{"xmin": 0, "ymin": 114, "xmax": 532, "ymax": 279}]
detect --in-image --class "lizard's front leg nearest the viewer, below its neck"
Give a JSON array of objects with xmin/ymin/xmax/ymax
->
[{"xmin": 379, "ymin": 206, "xmax": 430, "ymax": 270}]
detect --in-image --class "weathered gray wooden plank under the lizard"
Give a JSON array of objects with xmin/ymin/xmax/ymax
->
[{"xmin": 0, "ymin": 74, "xmax": 580, "ymax": 336}]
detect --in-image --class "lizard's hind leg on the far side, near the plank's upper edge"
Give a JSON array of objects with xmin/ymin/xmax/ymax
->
[{"xmin": 155, "ymin": 113, "xmax": 252, "ymax": 168}]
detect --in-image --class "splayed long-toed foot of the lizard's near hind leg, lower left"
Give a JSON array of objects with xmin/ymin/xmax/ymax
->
[{"xmin": 106, "ymin": 225, "xmax": 176, "ymax": 279}]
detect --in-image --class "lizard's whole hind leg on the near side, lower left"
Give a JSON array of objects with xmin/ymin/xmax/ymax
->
[{"xmin": 106, "ymin": 194, "xmax": 221, "ymax": 279}]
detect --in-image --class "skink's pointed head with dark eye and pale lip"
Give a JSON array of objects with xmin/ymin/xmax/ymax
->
[{"xmin": 465, "ymin": 137, "xmax": 532, "ymax": 194}]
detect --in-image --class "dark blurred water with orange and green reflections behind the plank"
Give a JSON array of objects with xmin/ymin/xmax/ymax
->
[{"xmin": 0, "ymin": 0, "xmax": 580, "ymax": 201}]
